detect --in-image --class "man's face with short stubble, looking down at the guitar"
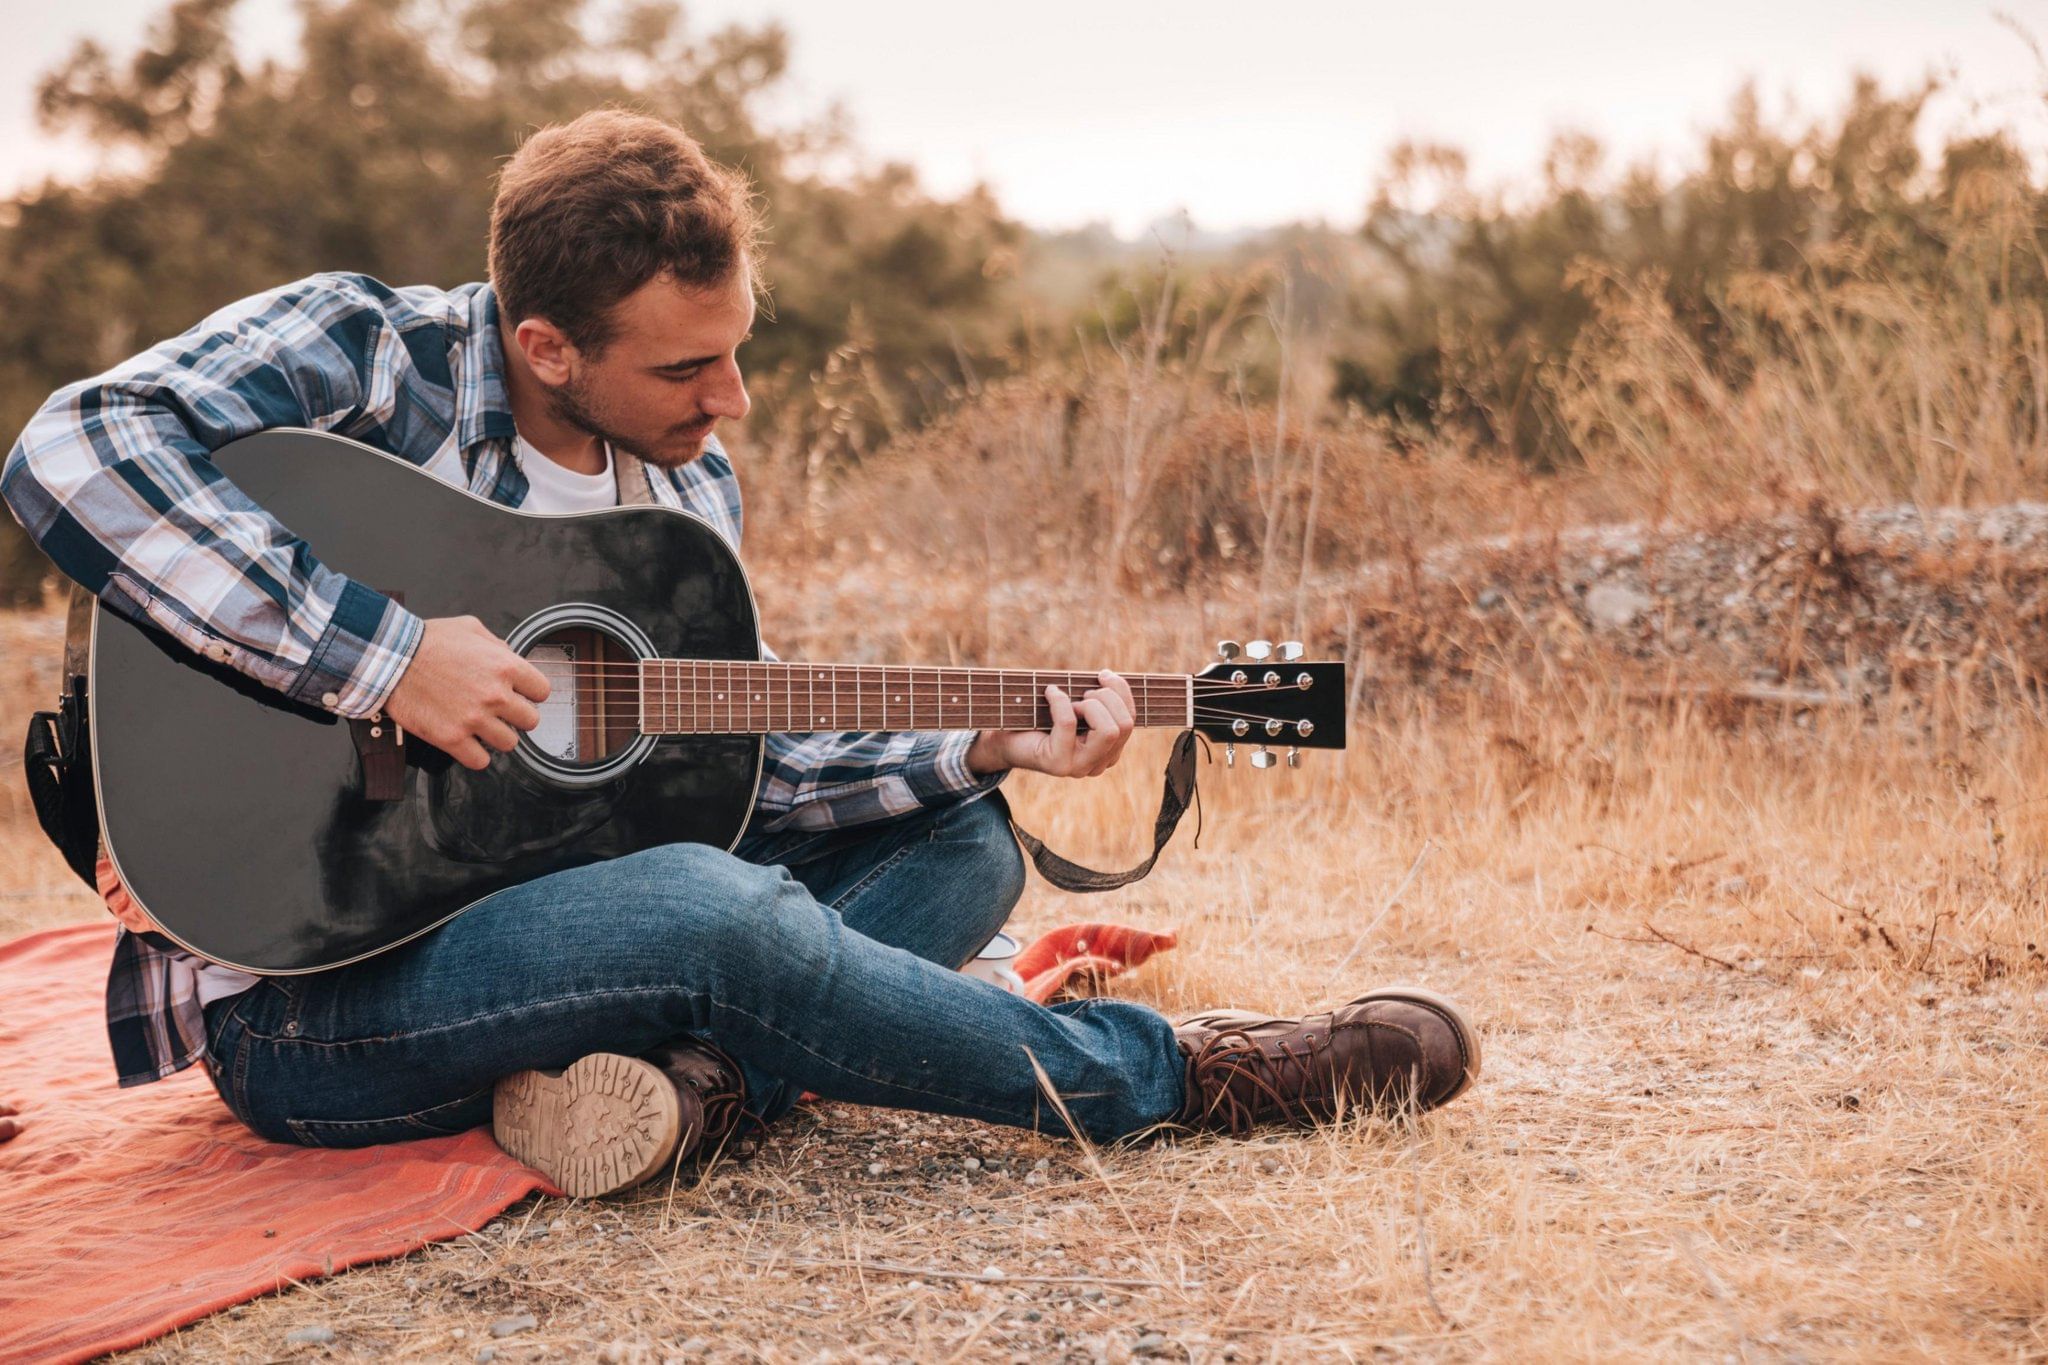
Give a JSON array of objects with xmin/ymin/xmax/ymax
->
[{"xmin": 547, "ymin": 270, "xmax": 754, "ymax": 467}]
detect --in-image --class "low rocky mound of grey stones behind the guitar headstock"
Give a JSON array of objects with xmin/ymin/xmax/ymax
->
[{"xmin": 1325, "ymin": 503, "xmax": 2048, "ymax": 704}]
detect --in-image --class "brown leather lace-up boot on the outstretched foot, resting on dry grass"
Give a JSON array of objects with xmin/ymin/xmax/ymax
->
[{"xmin": 1174, "ymin": 986, "xmax": 1479, "ymax": 1136}]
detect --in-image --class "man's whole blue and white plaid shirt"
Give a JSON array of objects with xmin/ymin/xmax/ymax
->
[{"xmin": 0, "ymin": 274, "xmax": 999, "ymax": 1085}]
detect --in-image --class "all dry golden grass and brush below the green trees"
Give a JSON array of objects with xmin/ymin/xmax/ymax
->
[{"xmin": 0, "ymin": 235, "xmax": 2048, "ymax": 1361}]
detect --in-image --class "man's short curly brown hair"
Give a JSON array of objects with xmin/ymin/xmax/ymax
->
[{"xmin": 489, "ymin": 108, "xmax": 760, "ymax": 354}]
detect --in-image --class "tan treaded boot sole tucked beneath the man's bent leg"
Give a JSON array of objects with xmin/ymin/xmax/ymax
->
[{"xmin": 492, "ymin": 1052, "xmax": 682, "ymax": 1199}]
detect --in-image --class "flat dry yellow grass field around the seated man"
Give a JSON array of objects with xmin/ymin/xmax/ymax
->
[{"xmin": 0, "ymin": 583, "xmax": 2048, "ymax": 1361}]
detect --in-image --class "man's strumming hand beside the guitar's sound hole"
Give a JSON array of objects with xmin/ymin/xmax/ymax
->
[{"xmin": 385, "ymin": 616, "xmax": 549, "ymax": 767}]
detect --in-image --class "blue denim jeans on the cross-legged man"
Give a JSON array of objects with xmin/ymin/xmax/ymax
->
[{"xmin": 207, "ymin": 800, "xmax": 1182, "ymax": 1146}]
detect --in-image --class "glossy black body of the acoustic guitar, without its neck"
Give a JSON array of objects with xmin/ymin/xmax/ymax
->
[{"xmin": 92, "ymin": 432, "xmax": 762, "ymax": 972}]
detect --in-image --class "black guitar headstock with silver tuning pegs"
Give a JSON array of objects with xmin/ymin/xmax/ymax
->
[{"xmin": 1194, "ymin": 641, "xmax": 1346, "ymax": 767}]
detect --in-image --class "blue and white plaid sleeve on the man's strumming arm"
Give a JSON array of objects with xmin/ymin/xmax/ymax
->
[{"xmin": 0, "ymin": 276, "xmax": 422, "ymax": 716}]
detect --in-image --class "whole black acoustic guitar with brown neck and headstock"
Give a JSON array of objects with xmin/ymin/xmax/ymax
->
[{"xmin": 88, "ymin": 430, "xmax": 1346, "ymax": 974}]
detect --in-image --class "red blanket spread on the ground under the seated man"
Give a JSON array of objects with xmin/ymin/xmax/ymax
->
[{"xmin": 0, "ymin": 925, "xmax": 549, "ymax": 1361}]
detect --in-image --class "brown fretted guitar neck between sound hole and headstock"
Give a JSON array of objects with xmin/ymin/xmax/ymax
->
[{"xmin": 637, "ymin": 659, "xmax": 1194, "ymax": 735}]
